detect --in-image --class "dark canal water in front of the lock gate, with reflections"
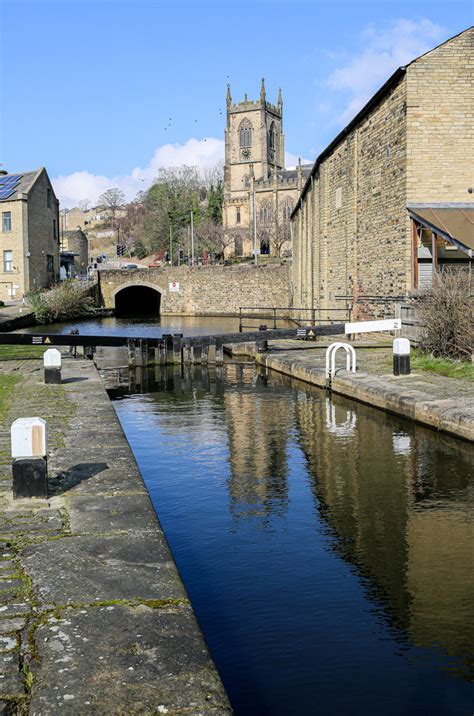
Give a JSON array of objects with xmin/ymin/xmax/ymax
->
[{"xmin": 106, "ymin": 363, "xmax": 474, "ymax": 716}]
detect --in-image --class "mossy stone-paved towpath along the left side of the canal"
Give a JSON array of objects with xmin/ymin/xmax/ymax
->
[{"xmin": 0, "ymin": 359, "xmax": 231, "ymax": 716}]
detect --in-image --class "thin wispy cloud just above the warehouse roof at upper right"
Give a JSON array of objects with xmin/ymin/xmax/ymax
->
[{"xmin": 327, "ymin": 19, "xmax": 445, "ymax": 124}]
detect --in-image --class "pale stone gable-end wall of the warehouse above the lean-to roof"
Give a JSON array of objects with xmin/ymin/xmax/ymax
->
[{"xmin": 407, "ymin": 28, "xmax": 474, "ymax": 203}]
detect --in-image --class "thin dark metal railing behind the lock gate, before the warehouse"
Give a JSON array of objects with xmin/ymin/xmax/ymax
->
[{"xmin": 239, "ymin": 306, "xmax": 352, "ymax": 333}]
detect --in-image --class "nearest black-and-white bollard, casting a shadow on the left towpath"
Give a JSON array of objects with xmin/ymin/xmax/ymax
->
[{"xmin": 11, "ymin": 418, "xmax": 48, "ymax": 499}]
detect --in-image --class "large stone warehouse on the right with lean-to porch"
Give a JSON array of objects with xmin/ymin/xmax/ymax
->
[{"xmin": 292, "ymin": 28, "xmax": 474, "ymax": 317}]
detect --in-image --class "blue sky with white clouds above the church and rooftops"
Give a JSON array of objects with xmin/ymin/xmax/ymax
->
[{"xmin": 0, "ymin": 0, "xmax": 473, "ymax": 206}]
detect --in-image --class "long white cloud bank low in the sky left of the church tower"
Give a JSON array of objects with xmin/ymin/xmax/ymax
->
[{"xmin": 52, "ymin": 137, "xmax": 224, "ymax": 209}]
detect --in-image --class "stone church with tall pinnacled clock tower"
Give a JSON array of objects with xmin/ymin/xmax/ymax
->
[{"xmin": 223, "ymin": 79, "xmax": 311, "ymax": 256}]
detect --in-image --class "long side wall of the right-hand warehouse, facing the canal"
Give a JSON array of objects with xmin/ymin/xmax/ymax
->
[{"xmin": 293, "ymin": 74, "xmax": 409, "ymax": 316}]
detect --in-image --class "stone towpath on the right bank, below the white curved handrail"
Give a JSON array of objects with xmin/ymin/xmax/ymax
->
[{"xmin": 232, "ymin": 335, "xmax": 474, "ymax": 440}]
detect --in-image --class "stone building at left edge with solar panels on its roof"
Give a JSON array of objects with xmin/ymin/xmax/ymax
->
[{"xmin": 0, "ymin": 167, "xmax": 59, "ymax": 300}]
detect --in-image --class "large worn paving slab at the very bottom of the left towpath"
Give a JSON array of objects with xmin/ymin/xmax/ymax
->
[{"xmin": 31, "ymin": 605, "xmax": 229, "ymax": 716}]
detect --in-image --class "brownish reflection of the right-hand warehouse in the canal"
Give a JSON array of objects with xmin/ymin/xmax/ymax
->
[{"xmin": 296, "ymin": 392, "xmax": 474, "ymax": 680}]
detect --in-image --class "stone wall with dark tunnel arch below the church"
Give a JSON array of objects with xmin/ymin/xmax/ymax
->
[{"xmin": 99, "ymin": 265, "xmax": 290, "ymax": 316}]
